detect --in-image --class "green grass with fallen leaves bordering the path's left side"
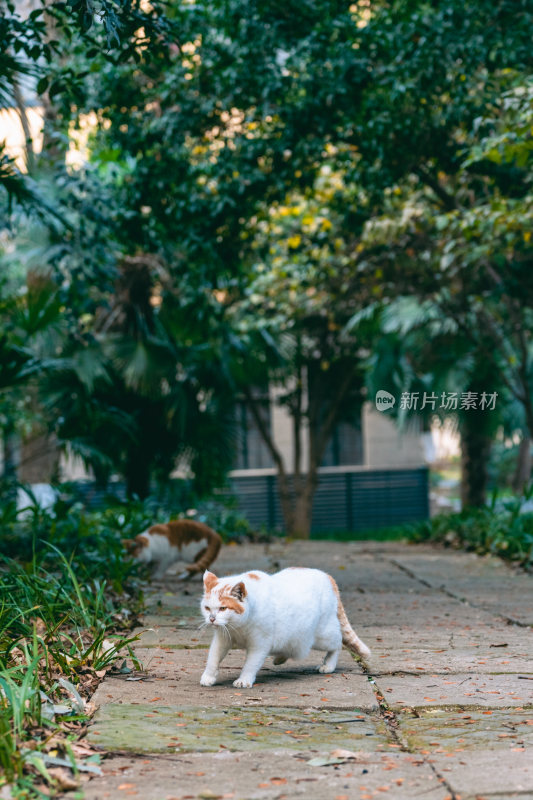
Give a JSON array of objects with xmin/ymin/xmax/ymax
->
[{"xmin": 0, "ymin": 490, "xmax": 145, "ymax": 800}]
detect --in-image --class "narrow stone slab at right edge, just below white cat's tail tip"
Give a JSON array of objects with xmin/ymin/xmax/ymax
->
[{"xmin": 376, "ymin": 673, "xmax": 533, "ymax": 708}]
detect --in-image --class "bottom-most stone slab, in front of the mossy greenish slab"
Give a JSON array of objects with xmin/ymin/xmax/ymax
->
[{"xmin": 86, "ymin": 750, "xmax": 450, "ymax": 800}]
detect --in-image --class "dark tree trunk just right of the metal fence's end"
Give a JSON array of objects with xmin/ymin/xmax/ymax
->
[{"xmin": 460, "ymin": 410, "xmax": 492, "ymax": 508}]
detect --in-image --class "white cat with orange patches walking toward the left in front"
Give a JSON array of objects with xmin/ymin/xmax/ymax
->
[{"xmin": 200, "ymin": 567, "xmax": 370, "ymax": 688}]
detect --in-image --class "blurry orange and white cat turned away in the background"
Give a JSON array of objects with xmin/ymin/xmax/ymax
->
[{"xmin": 122, "ymin": 519, "xmax": 222, "ymax": 579}]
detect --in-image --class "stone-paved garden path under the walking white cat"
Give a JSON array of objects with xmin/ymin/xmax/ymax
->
[{"xmin": 86, "ymin": 541, "xmax": 533, "ymax": 800}]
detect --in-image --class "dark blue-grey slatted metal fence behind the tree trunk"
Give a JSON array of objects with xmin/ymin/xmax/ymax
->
[{"xmin": 231, "ymin": 467, "xmax": 429, "ymax": 532}]
